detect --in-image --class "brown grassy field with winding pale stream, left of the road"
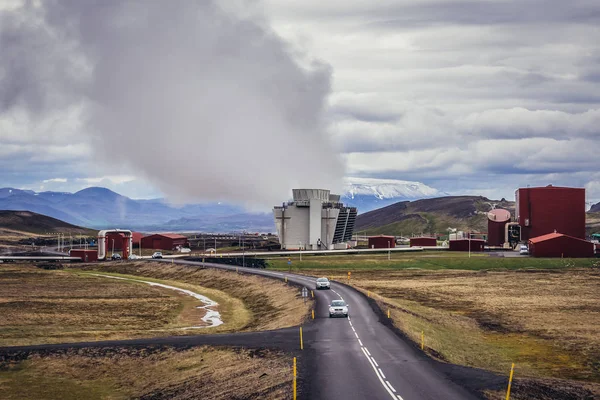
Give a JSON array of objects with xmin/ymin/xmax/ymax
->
[{"xmin": 0, "ymin": 262, "xmax": 309, "ymax": 346}]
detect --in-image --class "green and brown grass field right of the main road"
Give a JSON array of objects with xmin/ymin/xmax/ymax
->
[{"xmin": 269, "ymin": 253, "xmax": 600, "ymax": 395}]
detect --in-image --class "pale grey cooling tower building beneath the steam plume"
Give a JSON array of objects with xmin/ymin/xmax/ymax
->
[{"xmin": 273, "ymin": 189, "xmax": 357, "ymax": 250}]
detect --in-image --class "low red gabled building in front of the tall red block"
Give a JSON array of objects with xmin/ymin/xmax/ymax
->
[{"xmin": 529, "ymin": 233, "xmax": 595, "ymax": 258}]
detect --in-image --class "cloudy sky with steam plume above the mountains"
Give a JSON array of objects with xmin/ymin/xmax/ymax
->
[{"xmin": 0, "ymin": 0, "xmax": 600, "ymax": 203}]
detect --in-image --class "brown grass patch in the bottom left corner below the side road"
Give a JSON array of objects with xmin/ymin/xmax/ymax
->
[{"xmin": 0, "ymin": 347, "xmax": 292, "ymax": 400}]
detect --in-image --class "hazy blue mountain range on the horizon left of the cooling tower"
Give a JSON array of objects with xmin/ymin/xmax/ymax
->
[{"xmin": 0, "ymin": 187, "xmax": 275, "ymax": 232}]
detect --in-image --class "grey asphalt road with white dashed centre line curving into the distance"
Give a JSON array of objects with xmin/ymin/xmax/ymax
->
[{"xmin": 164, "ymin": 261, "xmax": 503, "ymax": 400}]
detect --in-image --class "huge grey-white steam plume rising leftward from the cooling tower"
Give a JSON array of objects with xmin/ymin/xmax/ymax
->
[{"xmin": 0, "ymin": 0, "xmax": 343, "ymax": 205}]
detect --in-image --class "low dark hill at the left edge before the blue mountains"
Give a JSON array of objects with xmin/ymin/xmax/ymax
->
[{"xmin": 0, "ymin": 210, "xmax": 97, "ymax": 236}]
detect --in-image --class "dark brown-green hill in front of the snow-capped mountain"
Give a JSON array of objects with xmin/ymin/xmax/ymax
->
[{"xmin": 354, "ymin": 196, "xmax": 514, "ymax": 235}]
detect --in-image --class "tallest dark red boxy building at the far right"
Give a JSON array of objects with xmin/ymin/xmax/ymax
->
[{"xmin": 515, "ymin": 185, "xmax": 585, "ymax": 240}]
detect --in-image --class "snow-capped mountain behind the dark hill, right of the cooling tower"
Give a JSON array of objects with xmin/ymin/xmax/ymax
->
[{"xmin": 341, "ymin": 178, "xmax": 447, "ymax": 213}]
